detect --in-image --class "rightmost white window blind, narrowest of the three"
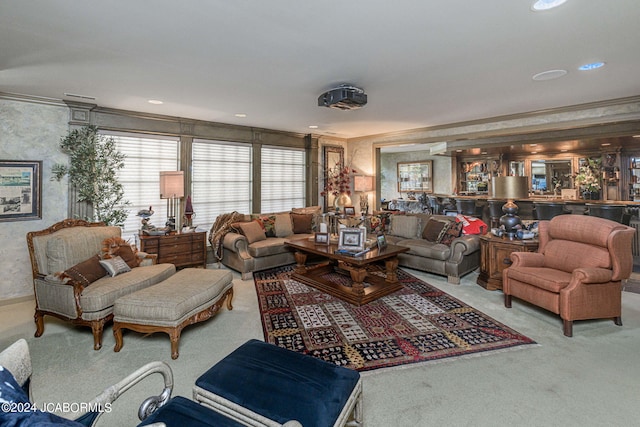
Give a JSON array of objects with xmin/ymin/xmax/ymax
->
[{"xmin": 260, "ymin": 147, "xmax": 306, "ymax": 213}]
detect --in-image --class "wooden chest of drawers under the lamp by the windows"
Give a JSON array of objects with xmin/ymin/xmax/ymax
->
[{"xmin": 140, "ymin": 232, "xmax": 207, "ymax": 268}]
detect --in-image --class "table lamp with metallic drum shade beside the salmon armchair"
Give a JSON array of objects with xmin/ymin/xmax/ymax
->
[{"xmin": 491, "ymin": 176, "xmax": 529, "ymax": 240}]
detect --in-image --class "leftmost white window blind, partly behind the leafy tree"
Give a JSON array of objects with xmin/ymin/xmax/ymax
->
[{"xmin": 104, "ymin": 132, "xmax": 180, "ymax": 243}]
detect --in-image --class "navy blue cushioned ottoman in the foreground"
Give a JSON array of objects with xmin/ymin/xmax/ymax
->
[{"xmin": 193, "ymin": 340, "xmax": 362, "ymax": 427}]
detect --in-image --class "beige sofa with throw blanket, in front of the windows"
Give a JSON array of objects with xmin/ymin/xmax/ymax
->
[{"xmin": 220, "ymin": 206, "xmax": 321, "ymax": 280}]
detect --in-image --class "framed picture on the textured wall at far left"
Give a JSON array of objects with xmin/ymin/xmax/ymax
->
[{"xmin": 0, "ymin": 160, "xmax": 42, "ymax": 221}]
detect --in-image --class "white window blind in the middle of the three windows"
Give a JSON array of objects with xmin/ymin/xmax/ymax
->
[{"xmin": 191, "ymin": 139, "xmax": 253, "ymax": 230}]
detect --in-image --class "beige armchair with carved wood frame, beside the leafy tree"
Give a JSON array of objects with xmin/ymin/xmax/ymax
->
[{"xmin": 27, "ymin": 219, "xmax": 176, "ymax": 350}]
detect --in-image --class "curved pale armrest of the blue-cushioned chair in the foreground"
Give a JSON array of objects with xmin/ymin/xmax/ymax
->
[{"xmin": 70, "ymin": 361, "xmax": 173, "ymax": 425}]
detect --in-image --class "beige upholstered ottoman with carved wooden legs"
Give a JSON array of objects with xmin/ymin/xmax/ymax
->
[{"xmin": 113, "ymin": 268, "xmax": 233, "ymax": 359}]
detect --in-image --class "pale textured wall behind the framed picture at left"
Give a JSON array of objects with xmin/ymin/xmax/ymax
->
[{"xmin": 0, "ymin": 99, "xmax": 69, "ymax": 301}]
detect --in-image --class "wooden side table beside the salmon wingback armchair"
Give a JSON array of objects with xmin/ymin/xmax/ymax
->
[{"xmin": 476, "ymin": 233, "xmax": 538, "ymax": 291}]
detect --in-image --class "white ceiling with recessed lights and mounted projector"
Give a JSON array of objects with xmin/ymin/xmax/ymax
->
[{"xmin": 0, "ymin": 0, "xmax": 640, "ymax": 138}]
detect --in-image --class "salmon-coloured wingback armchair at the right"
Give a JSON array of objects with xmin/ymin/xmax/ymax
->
[{"xmin": 502, "ymin": 215, "xmax": 635, "ymax": 337}]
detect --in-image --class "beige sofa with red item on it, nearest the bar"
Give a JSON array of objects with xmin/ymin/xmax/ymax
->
[{"xmin": 385, "ymin": 214, "xmax": 480, "ymax": 284}]
